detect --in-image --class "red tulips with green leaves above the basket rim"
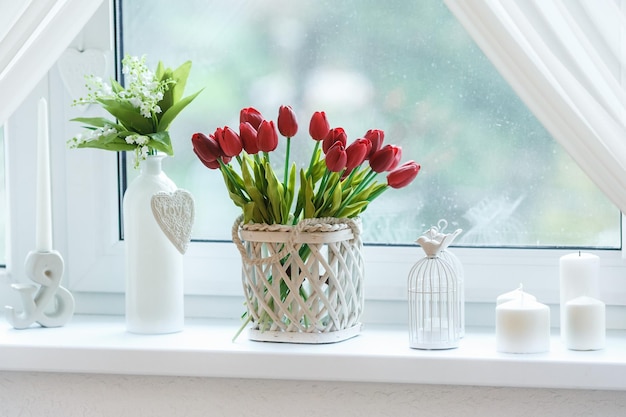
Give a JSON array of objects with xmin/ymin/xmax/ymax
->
[{"xmin": 191, "ymin": 106, "xmax": 420, "ymax": 224}]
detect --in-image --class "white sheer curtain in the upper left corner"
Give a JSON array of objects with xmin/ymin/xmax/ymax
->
[{"xmin": 0, "ymin": 0, "xmax": 103, "ymax": 125}]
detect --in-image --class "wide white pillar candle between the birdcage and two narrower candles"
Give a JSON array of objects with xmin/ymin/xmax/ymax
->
[{"xmin": 496, "ymin": 296, "xmax": 550, "ymax": 353}]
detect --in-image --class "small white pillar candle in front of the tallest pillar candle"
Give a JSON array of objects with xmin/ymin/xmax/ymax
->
[{"xmin": 564, "ymin": 296, "xmax": 606, "ymax": 350}]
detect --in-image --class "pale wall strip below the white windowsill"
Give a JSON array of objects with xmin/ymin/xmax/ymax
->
[{"xmin": 0, "ymin": 372, "xmax": 626, "ymax": 417}]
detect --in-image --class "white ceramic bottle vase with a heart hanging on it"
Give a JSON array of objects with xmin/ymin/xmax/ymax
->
[{"xmin": 124, "ymin": 155, "xmax": 185, "ymax": 334}]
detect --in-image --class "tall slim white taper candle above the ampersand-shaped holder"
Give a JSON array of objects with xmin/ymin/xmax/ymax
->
[{"xmin": 35, "ymin": 97, "xmax": 52, "ymax": 252}]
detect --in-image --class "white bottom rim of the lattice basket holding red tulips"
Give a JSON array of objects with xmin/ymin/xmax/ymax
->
[{"xmin": 248, "ymin": 323, "xmax": 362, "ymax": 344}]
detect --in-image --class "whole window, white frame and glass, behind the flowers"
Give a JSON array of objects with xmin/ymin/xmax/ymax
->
[{"xmin": 0, "ymin": 0, "xmax": 626, "ymax": 327}]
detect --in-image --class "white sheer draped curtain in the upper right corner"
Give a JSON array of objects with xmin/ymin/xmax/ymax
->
[{"xmin": 444, "ymin": 0, "xmax": 626, "ymax": 212}]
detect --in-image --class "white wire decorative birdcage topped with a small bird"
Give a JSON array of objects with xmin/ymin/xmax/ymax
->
[{"xmin": 408, "ymin": 229, "xmax": 461, "ymax": 349}]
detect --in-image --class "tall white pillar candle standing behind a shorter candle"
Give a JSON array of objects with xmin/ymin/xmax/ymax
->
[{"xmin": 559, "ymin": 252, "xmax": 600, "ymax": 340}]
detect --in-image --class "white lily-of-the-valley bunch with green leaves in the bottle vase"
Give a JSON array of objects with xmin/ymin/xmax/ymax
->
[{"xmin": 68, "ymin": 55, "xmax": 200, "ymax": 168}]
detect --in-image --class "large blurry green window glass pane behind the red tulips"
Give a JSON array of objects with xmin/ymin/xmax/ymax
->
[{"xmin": 122, "ymin": 0, "xmax": 620, "ymax": 247}]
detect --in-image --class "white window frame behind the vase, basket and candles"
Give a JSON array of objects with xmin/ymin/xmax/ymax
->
[{"xmin": 5, "ymin": 2, "xmax": 626, "ymax": 328}]
